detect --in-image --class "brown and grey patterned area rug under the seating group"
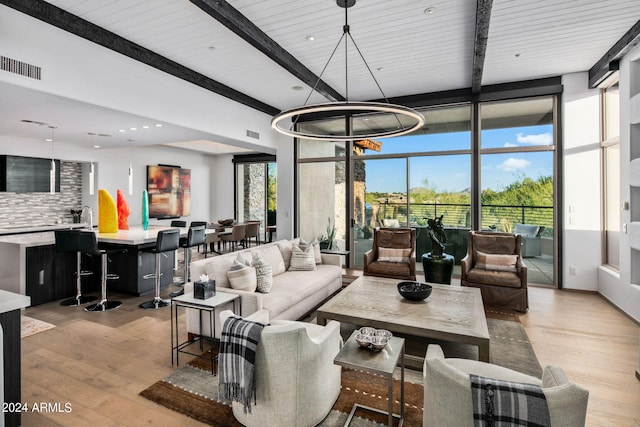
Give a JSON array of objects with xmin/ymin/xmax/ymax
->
[{"xmin": 140, "ymin": 317, "xmax": 542, "ymax": 427}]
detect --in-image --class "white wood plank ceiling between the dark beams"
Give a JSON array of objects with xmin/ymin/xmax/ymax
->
[{"xmin": 10, "ymin": 0, "xmax": 640, "ymax": 113}]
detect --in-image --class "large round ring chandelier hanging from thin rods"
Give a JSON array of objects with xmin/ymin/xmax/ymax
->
[{"xmin": 271, "ymin": 0, "xmax": 424, "ymax": 141}]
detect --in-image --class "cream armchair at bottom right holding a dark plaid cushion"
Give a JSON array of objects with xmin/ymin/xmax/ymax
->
[{"xmin": 423, "ymin": 344, "xmax": 589, "ymax": 427}]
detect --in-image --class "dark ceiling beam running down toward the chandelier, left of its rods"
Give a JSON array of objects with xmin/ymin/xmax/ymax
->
[{"xmin": 191, "ymin": 0, "xmax": 345, "ymax": 101}]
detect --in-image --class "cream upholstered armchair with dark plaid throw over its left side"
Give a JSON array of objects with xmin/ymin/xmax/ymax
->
[{"xmin": 220, "ymin": 310, "xmax": 342, "ymax": 427}]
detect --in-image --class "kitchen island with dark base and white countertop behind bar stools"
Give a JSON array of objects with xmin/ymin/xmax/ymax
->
[{"xmin": 0, "ymin": 226, "xmax": 188, "ymax": 305}]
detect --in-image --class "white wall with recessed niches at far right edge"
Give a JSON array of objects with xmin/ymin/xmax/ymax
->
[{"xmin": 598, "ymin": 47, "xmax": 640, "ymax": 322}]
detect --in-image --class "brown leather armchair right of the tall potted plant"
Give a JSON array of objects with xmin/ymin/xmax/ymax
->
[{"xmin": 460, "ymin": 231, "xmax": 529, "ymax": 312}]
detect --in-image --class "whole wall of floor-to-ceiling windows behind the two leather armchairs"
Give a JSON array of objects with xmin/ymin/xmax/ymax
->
[{"xmin": 297, "ymin": 91, "xmax": 557, "ymax": 284}]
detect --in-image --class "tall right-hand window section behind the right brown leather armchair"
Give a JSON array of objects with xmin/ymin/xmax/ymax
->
[{"xmin": 478, "ymin": 97, "xmax": 556, "ymax": 285}]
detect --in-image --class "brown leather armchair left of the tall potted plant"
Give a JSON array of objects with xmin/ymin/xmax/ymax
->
[{"xmin": 363, "ymin": 228, "xmax": 416, "ymax": 280}]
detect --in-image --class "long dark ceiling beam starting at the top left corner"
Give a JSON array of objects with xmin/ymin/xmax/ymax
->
[{"xmin": 0, "ymin": 0, "xmax": 280, "ymax": 116}]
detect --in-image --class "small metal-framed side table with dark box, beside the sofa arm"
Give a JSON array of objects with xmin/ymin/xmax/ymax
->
[{"xmin": 170, "ymin": 292, "xmax": 242, "ymax": 375}]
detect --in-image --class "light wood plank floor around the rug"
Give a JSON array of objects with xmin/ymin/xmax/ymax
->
[{"xmin": 17, "ymin": 280, "xmax": 640, "ymax": 427}]
